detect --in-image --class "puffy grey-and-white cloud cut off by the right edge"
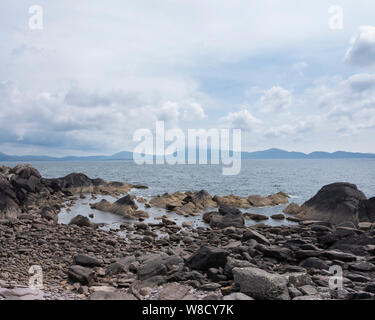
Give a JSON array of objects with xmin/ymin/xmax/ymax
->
[{"xmin": 345, "ymin": 26, "xmax": 375, "ymax": 67}]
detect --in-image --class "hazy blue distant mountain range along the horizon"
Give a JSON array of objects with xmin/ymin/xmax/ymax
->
[{"xmin": 0, "ymin": 148, "xmax": 375, "ymax": 162}]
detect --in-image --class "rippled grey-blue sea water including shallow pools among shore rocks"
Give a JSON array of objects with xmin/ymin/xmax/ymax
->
[{"xmin": 1, "ymin": 159, "xmax": 375, "ymax": 226}]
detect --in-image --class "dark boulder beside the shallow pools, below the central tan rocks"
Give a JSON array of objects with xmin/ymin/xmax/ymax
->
[{"xmin": 203, "ymin": 206, "xmax": 245, "ymax": 229}]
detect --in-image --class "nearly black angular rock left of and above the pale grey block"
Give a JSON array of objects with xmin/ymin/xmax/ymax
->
[{"xmin": 186, "ymin": 246, "xmax": 229, "ymax": 270}]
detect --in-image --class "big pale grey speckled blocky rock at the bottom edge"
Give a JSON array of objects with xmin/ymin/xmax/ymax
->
[{"xmin": 233, "ymin": 267, "xmax": 288, "ymax": 300}]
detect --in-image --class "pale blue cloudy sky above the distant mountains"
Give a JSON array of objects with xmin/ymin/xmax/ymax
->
[{"xmin": 0, "ymin": 0, "xmax": 375, "ymax": 156}]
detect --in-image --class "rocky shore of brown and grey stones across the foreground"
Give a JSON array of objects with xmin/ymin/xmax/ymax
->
[{"xmin": 0, "ymin": 165, "xmax": 375, "ymax": 300}]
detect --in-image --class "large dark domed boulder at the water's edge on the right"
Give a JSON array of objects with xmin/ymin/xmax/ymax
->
[{"xmin": 297, "ymin": 182, "xmax": 366, "ymax": 225}]
